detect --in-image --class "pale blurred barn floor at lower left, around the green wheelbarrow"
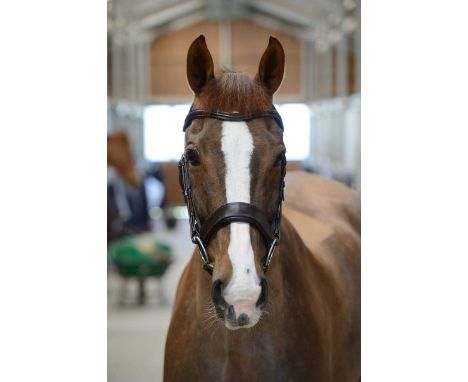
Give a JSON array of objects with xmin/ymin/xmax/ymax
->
[{"xmin": 107, "ymin": 220, "xmax": 193, "ymax": 382}]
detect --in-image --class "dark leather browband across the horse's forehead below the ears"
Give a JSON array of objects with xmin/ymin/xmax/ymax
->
[{"xmin": 183, "ymin": 105, "xmax": 284, "ymax": 132}]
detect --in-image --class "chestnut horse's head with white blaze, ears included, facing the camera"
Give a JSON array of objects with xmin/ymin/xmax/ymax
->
[{"xmin": 183, "ymin": 36, "xmax": 285, "ymax": 330}]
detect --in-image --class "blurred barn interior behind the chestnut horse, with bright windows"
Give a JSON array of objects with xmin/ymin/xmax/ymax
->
[{"xmin": 107, "ymin": 0, "xmax": 361, "ymax": 381}]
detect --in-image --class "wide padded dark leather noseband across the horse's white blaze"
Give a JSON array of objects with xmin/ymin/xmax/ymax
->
[{"xmin": 200, "ymin": 202, "xmax": 273, "ymax": 248}]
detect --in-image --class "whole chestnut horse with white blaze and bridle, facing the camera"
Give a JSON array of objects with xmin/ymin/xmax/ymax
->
[{"xmin": 163, "ymin": 35, "xmax": 361, "ymax": 382}]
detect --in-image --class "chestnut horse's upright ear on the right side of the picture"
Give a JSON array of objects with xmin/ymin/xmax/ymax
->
[{"xmin": 256, "ymin": 36, "xmax": 284, "ymax": 95}]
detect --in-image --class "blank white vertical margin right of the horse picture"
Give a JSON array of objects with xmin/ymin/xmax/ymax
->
[{"xmin": 362, "ymin": 1, "xmax": 468, "ymax": 382}]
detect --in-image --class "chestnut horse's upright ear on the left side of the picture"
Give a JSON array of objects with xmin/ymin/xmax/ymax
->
[{"xmin": 187, "ymin": 35, "xmax": 214, "ymax": 94}]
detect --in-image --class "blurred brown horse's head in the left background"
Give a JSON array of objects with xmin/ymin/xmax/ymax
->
[{"xmin": 107, "ymin": 130, "xmax": 140, "ymax": 186}]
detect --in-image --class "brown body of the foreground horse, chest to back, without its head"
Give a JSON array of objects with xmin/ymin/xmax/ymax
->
[{"xmin": 164, "ymin": 173, "xmax": 361, "ymax": 382}]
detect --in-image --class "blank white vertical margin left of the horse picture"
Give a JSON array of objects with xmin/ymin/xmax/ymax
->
[{"xmin": 0, "ymin": 1, "xmax": 107, "ymax": 382}]
